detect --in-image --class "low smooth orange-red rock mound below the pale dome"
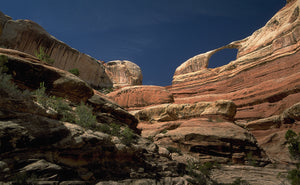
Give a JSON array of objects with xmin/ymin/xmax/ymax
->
[{"xmin": 107, "ymin": 85, "xmax": 174, "ymax": 109}]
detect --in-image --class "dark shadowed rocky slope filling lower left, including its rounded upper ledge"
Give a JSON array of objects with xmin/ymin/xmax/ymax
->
[{"xmin": 0, "ymin": 49, "xmax": 189, "ymax": 185}]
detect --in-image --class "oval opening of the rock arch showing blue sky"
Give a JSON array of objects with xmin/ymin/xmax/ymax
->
[{"xmin": 208, "ymin": 48, "xmax": 238, "ymax": 68}]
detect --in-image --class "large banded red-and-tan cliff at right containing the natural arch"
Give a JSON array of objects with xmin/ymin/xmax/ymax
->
[{"xmin": 168, "ymin": 0, "xmax": 300, "ymax": 121}]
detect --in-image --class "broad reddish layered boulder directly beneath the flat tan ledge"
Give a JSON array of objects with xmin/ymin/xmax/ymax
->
[{"xmin": 138, "ymin": 118, "xmax": 269, "ymax": 165}]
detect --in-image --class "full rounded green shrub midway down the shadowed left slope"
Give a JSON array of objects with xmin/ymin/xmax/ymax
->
[{"xmin": 75, "ymin": 102, "xmax": 97, "ymax": 129}]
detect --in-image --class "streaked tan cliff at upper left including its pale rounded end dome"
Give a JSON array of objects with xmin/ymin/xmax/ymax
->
[{"xmin": 0, "ymin": 12, "xmax": 142, "ymax": 88}]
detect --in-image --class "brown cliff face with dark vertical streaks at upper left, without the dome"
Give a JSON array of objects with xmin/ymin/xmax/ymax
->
[{"xmin": 0, "ymin": 12, "xmax": 113, "ymax": 87}]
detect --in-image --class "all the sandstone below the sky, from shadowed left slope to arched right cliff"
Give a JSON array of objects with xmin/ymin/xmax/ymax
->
[{"xmin": 0, "ymin": 0, "xmax": 300, "ymax": 185}]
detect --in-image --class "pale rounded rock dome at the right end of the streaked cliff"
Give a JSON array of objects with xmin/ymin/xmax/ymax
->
[{"xmin": 104, "ymin": 60, "xmax": 143, "ymax": 87}]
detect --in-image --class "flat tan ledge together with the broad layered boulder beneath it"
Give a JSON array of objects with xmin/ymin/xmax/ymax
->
[{"xmin": 135, "ymin": 100, "xmax": 268, "ymax": 165}]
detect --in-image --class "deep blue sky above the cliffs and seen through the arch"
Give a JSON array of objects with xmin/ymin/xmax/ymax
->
[{"xmin": 0, "ymin": 0, "xmax": 285, "ymax": 86}]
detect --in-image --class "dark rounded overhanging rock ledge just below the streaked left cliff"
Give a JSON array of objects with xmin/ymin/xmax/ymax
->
[{"xmin": 0, "ymin": 49, "xmax": 94, "ymax": 102}]
